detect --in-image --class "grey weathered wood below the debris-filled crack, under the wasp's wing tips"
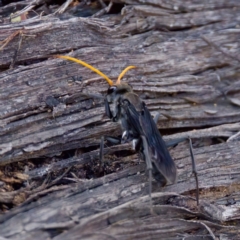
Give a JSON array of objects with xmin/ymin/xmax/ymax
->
[{"xmin": 0, "ymin": 142, "xmax": 240, "ymax": 239}]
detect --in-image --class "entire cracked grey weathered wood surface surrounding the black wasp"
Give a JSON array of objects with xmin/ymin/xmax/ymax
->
[{"xmin": 0, "ymin": 0, "xmax": 240, "ymax": 240}]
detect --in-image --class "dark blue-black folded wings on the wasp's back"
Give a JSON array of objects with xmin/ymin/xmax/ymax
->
[{"xmin": 124, "ymin": 101, "xmax": 177, "ymax": 183}]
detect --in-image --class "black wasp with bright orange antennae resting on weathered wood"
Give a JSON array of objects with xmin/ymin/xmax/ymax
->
[{"xmin": 56, "ymin": 55, "xmax": 198, "ymax": 206}]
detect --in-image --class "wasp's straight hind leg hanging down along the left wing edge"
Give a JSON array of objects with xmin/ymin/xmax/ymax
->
[{"xmin": 141, "ymin": 136, "xmax": 153, "ymax": 213}]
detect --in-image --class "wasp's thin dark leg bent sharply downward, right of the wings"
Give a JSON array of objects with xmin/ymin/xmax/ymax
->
[{"xmin": 166, "ymin": 137, "xmax": 199, "ymax": 205}]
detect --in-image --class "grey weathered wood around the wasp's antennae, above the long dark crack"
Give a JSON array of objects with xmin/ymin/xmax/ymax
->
[{"xmin": 0, "ymin": 14, "xmax": 240, "ymax": 165}]
